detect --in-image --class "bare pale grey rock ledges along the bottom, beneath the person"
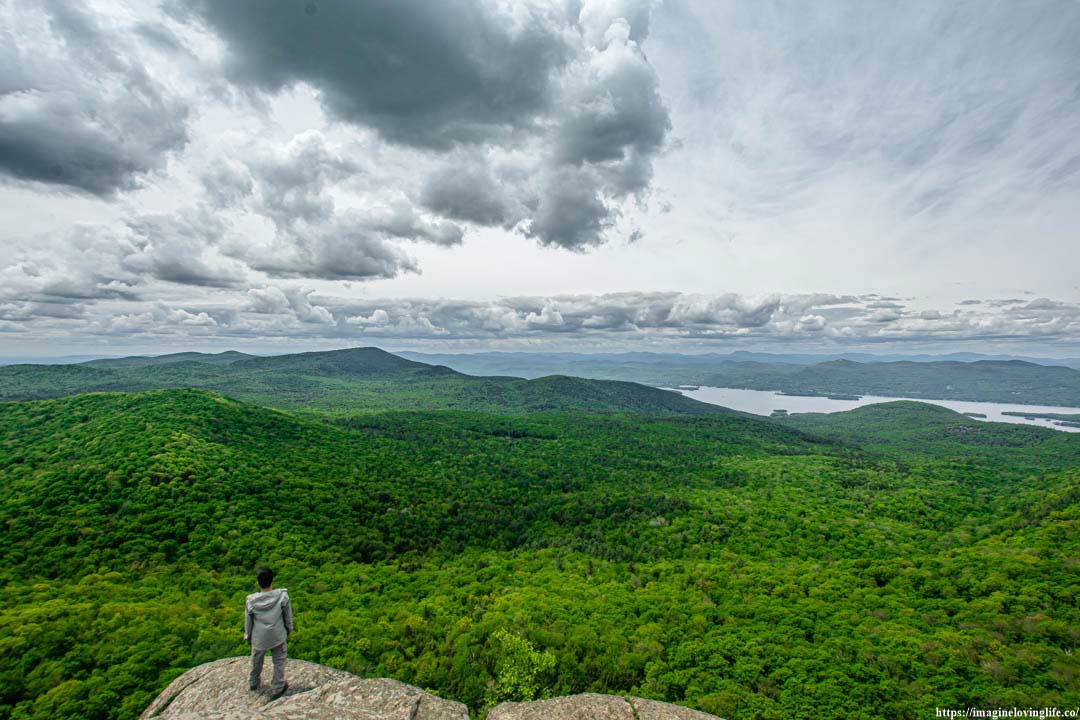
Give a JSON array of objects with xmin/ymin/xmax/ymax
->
[{"xmin": 140, "ymin": 657, "xmax": 716, "ymax": 720}]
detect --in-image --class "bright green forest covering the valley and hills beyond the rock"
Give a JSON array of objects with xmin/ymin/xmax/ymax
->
[{"xmin": 0, "ymin": 353, "xmax": 1080, "ymax": 720}]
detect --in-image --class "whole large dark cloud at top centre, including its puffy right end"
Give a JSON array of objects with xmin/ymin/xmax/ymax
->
[{"xmin": 184, "ymin": 0, "xmax": 671, "ymax": 250}]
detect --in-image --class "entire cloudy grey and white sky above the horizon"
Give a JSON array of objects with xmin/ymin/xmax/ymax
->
[{"xmin": 0, "ymin": 0, "xmax": 1080, "ymax": 357}]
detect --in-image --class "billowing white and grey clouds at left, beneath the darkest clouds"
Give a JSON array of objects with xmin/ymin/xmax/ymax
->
[{"xmin": 0, "ymin": 124, "xmax": 463, "ymax": 293}]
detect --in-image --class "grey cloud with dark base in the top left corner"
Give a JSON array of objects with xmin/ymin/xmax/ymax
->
[{"xmin": 0, "ymin": 0, "xmax": 188, "ymax": 195}]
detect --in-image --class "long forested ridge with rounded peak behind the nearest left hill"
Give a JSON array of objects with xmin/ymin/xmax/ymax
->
[{"xmin": 0, "ymin": 348, "xmax": 730, "ymax": 415}]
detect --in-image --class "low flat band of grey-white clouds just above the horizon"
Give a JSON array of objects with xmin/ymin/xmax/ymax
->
[{"xmin": 8, "ymin": 280, "xmax": 1080, "ymax": 354}]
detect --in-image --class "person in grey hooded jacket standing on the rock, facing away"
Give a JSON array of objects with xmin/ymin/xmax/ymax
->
[{"xmin": 244, "ymin": 568, "xmax": 293, "ymax": 699}]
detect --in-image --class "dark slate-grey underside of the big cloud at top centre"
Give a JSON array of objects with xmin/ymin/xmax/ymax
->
[{"xmin": 177, "ymin": 0, "xmax": 572, "ymax": 149}]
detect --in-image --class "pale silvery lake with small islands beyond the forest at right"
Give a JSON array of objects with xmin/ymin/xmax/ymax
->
[{"xmin": 665, "ymin": 385, "xmax": 1080, "ymax": 433}]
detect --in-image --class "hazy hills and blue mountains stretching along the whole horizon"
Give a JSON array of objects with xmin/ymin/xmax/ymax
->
[{"xmin": 0, "ymin": 348, "xmax": 1080, "ymax": 413}]
